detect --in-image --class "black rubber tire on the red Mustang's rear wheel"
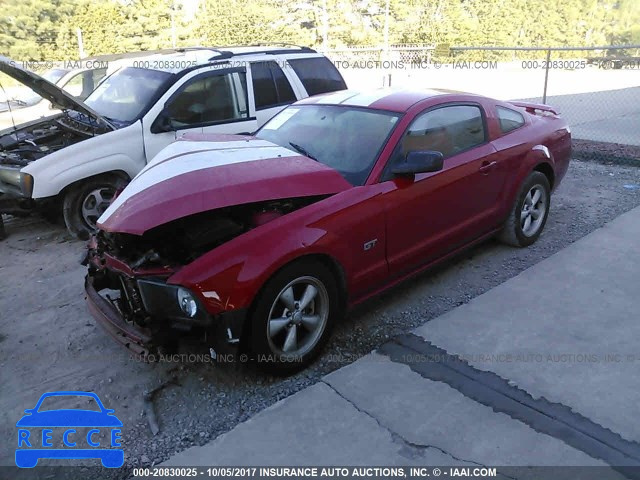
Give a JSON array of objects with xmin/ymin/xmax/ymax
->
[{"xmin": 498, "ymin": 172, "xmax": 551, "ymax": 247}]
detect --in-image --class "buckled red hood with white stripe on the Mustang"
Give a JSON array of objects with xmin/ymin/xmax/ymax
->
[{"xmin": 98, "ymin": 135, "xmax": 351, "ymax": 235}]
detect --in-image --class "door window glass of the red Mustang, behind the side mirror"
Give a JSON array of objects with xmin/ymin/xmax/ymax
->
[{"xmin": 402, "ymin": 105, "xmax": 485, "ymax": 158}]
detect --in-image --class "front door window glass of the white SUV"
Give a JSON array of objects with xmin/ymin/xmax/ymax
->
[{"xmin": 166, "ymin": 72, "xmax": 248, "ymax": 128}]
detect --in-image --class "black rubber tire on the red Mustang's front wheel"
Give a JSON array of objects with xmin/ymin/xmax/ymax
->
[{"xmin": 246, "ymin": 260, "xmax": 342, "ymax": 375}]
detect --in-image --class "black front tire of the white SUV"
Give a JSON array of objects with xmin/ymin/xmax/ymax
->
[{"xmin": 62, "ymin": 175, "xmax": 126, "ymax": 240}]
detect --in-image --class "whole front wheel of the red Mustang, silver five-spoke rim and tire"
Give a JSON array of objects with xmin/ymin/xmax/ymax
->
[{"xmin": 249, "ymin": 261, "xmax": 339, "ymax": 374}]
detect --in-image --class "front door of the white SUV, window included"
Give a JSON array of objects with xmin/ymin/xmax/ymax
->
[{"xmin": 143, "ymin": 68, "xmax": 257, "ymax": 162}]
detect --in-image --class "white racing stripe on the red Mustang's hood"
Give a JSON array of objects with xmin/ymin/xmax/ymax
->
[{"xmin": 98, "ymin": 142, "xmax": 299, "ymax": 223}]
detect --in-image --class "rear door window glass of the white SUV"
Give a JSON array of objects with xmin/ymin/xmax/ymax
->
[{"xmin": 251, "ymin": 61, "xmax": 296, "ymax": 110}]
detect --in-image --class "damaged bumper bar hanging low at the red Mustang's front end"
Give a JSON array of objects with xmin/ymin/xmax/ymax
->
[{"xmin": 84, "ymin": 275, "xmax": 153, "ymax": 358}]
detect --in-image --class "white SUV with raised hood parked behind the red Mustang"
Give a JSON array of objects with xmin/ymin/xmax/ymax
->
[{"xmin": 0, "ymin": 47, "xmax": 346, "ymax": 237}]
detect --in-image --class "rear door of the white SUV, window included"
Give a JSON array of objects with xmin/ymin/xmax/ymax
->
[{"xmin": 251, "ymin": 60, "xmax": 297, "ymax": 127}]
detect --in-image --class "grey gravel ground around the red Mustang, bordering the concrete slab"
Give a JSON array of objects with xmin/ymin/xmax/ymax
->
[{"xmin": 0, "ymin": 161, "xmax": 640, "ymax": 478}]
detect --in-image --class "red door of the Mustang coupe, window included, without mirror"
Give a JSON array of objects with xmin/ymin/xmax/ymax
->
[{"xmin": 382, "ymin": 103, "xmax": 504, "ymax": 275}]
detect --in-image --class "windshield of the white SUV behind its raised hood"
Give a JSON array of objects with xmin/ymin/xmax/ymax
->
[{"xmin": 84, "ymin": 68, "xmax": 171, "ymax": 123}]
